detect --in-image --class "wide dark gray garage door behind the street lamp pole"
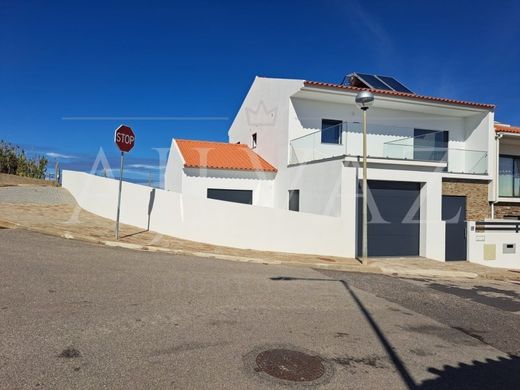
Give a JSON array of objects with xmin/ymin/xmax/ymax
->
[{"xmin": 358, "ymin": 180, "xmax": 420, "ymax": 256}]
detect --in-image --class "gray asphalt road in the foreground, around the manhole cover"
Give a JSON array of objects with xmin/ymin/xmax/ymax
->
[{"xmin": 0, "ymin": 230, "xmax": 520, "ymax": 389}]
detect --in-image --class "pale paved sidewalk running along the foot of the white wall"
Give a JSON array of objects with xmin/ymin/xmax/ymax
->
[{"xmin": 0, "ymin": 181, "xmax": 520, "ymax": 282}]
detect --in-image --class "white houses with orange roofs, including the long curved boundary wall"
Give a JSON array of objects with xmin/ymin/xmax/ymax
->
[{"xmin": 63, "ymin": 73, "xmax": 520, "ymax": 269}]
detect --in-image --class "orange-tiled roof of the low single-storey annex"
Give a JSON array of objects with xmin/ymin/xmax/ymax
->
[{"xmin": 175, "ymin": 139, "xmax": 276, "ymax": 172}]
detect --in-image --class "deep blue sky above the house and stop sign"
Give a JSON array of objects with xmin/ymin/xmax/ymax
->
[{"xmin": 0, "ymin": 0, "xmax": 520, "ymax": 183}]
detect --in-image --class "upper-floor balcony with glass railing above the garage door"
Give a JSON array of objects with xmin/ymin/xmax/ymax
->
[{"xmin": 289, "ymin": 122, "xmax": 488, "ymax": 175}]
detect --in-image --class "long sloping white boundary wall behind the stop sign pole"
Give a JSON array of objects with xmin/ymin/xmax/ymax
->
[{"xmin": 62, "ymin": 171, "xmax": 351, "ymax": 256}]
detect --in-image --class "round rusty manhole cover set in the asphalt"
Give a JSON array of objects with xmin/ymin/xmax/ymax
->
[{"xmin": 256, "ymin": 349, "xmax": 325, "ymax": 382}]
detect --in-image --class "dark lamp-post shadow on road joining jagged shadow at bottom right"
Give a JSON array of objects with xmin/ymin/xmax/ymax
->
[{"xmin": 271, "ymin": 276, "xmax": 520, "ymax": 390}]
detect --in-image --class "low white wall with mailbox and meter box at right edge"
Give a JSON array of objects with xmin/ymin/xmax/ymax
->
[{"xmin": 467, "ymin": 222, "xmax": 520, "ymax": 269}]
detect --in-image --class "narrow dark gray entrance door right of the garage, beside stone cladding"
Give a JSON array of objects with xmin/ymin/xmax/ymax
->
[{"xmin": 442, "ymin": 196, "xmax": 467, "ymax": 260}]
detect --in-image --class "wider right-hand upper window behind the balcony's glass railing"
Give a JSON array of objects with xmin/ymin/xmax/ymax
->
[{"xmin": 413, "ymin": 129, "xmax": 449, "ymax": 161}]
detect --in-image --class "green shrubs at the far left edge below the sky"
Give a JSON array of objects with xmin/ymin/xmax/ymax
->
[{"xmin": 0, "ymin": 141, "xmax": 49, "ymax": 179}]
